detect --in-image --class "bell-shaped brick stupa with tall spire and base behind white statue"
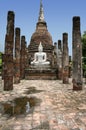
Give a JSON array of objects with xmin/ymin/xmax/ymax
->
[{"xmin": 25, "ymin": 0, "xmax": 57, "ymax": 79}]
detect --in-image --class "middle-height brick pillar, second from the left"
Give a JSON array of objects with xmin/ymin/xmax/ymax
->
[{"xmin": 14, "ymin": 28, "xmax": 20, "ymax": 84}]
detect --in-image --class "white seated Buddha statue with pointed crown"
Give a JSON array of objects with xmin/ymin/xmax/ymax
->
[{"xmin": 31, "ymin": 42, "xmax": 50, "ymax": 65}]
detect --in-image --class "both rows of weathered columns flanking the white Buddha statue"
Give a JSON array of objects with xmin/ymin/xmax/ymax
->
[{"xmin": 3, "ymin": 11, "xmax": 82, "ymax": 90}]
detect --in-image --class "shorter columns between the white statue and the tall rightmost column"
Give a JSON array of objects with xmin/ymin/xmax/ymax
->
[{"xmin": 55, "ymin": 33, "xmax": 69, "ymax": 84}]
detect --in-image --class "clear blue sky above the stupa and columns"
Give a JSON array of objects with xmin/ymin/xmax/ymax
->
[{"xmin": 0, "ymin": 0, "xmax": 86, "ymax": 55}]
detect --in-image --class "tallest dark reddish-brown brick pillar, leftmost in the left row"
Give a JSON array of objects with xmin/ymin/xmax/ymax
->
[{"xmin": 3, "ymin": 11, "xmax": 14, "ymax": 91}]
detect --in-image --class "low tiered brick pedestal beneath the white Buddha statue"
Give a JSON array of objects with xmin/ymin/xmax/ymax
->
[{"xmin": 25, "ymin": 65, "xmax": 57, "ymax": 80}]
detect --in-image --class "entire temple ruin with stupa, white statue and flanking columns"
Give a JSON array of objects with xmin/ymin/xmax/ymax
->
[{"xmin": 3, "ymin": 0, "xmax": 82, "ymax": 91}]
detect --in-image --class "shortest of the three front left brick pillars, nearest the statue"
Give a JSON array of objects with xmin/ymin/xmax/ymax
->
[{"xmin": 20, "ymin": 36, "xmax": 26, "ymax": 79}]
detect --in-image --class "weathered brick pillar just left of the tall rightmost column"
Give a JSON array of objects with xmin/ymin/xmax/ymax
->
[{"xmin": 62, "ymin": 33, "xmax": 69, "ymax": 84}]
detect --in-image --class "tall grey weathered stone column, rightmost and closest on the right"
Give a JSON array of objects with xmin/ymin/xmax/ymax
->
[{"xmin": 72, "ymin": 17, "xmax": 82, "ymax": 91}]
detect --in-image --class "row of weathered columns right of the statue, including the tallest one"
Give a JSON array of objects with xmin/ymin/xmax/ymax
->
[{"xmin": 57, "ymin": 17, "xmax": 83, "ymax": 91}]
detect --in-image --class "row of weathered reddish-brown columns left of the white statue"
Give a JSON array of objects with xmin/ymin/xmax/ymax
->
[{"xmin": 3, "ymin": 11, "xmax": 26, "ymax": 91}]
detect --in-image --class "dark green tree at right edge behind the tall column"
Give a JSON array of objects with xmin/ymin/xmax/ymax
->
[{"xmin": 82, "ymin": 31, "xmax": 86, "ymax": 76}]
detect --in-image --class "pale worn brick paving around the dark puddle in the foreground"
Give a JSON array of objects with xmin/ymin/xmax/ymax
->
[{"xmin": 0, "ymin": 79, "xmax": 86, "ymax": 130}]
